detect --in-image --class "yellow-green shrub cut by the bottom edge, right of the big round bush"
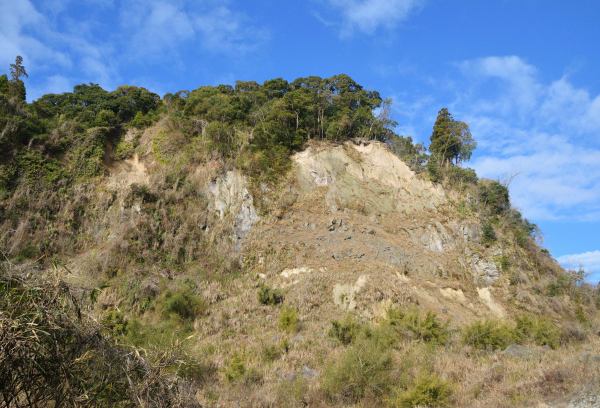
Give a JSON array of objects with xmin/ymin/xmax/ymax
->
[{"xmin": 390, "ymin": 374, "xmax": 452, "ymax": 408}]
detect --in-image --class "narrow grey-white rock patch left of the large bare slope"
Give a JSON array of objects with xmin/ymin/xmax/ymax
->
[{"xmin": 208, "ymin": 171, "xmax": 259, "ymax": 248}]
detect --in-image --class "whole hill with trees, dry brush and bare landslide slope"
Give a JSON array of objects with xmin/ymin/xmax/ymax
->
[{"xmin": 0, "ymin": 59, "xmax": 600, "ymax": 407}]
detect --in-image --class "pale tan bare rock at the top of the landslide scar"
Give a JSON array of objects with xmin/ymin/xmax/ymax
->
[{"xmin": 294, "ymin": 143, "xmax": 445, "ymax": 214}]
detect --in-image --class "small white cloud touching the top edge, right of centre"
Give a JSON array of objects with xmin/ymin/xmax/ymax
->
[{"xmin": 327, "ymin": 0, "xmax": 424, "ymax": 36}]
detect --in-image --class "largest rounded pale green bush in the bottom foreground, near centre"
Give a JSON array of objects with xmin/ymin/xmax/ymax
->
[{"xmin": 321, "ymin": 339, "xmax": 393, "ymax": 403}]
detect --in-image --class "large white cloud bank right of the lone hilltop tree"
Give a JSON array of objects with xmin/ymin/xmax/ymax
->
[{"xmin": 454, "ymin": 56, "xmax": 600, "ymax": 220}]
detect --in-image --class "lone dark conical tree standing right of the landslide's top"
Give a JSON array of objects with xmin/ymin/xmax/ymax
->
[{"xmin": 429, "ymin": 108, "xmax": 477, "ymax": 165}]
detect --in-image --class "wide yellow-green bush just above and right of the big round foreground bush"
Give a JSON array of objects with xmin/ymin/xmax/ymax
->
[{"xmin": 387, "ymin": 308, "xmax": 450, "ymax": 344}]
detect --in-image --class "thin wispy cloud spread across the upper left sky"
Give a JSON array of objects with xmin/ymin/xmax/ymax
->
[{"xmin": 0, "ymin": 0, "xmax": 269, "ymax": 98}]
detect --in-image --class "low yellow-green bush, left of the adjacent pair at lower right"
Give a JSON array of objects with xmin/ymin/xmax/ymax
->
[{"xmin": 462, "ymin": 320, "xmax": 517, "ymax": 350}]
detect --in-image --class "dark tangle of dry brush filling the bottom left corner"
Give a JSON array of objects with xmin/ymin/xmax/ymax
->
[{"xmin": 0, "ymin": 265, "xmax": 197, "ymax": 407}]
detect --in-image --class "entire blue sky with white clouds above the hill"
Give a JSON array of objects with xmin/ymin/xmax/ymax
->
[{"xmin": 0, "ymin": 0, "xmax": 600, "ymax": 280}]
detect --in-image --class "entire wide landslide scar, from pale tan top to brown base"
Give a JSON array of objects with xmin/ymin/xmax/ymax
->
[{"xmin": 239, "ymin": 142, "xmax": 520, "ymax": 322}]
